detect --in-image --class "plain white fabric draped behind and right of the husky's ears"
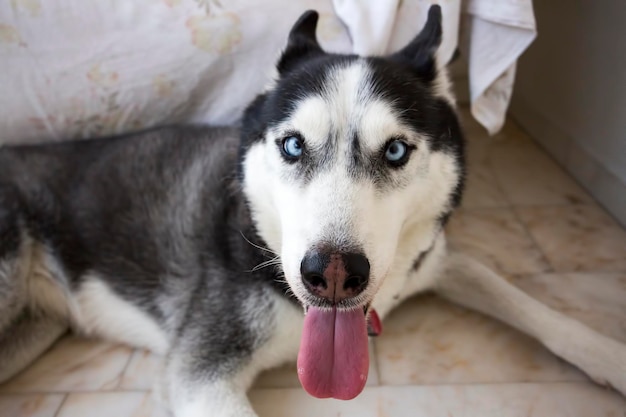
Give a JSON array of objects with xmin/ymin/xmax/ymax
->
[{"xmin": 334, "ymin": 0, "xmax": 537, "ymax": 134}]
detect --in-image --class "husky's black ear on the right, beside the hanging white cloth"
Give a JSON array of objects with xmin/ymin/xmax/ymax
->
[{"xmin": 391, "ymin": 4, "xmax": 442, "ymax": 81}]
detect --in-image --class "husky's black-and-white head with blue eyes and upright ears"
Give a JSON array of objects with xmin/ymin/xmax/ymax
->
[{"xmin": 241, "ymin": 6, "xmax": 463, "ymax": 398}]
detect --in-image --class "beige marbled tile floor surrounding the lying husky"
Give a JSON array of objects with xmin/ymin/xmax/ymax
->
[{"xmin": 0, "ymin": 111, "xmax": 626, "ymax": 417}]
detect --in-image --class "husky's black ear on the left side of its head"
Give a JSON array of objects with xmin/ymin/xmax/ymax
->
[{"xmin": 276, "ymin": 10, "xmax": 324, "ymax": 74}]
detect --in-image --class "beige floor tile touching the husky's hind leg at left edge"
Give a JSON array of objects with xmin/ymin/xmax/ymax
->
[{"xmin": 0, "ymin": 337, "xmax": 132, "ymax": 393}]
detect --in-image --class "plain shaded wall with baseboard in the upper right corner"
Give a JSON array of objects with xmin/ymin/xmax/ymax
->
[{"xmin": 511, "ymin": 0, "xmax": 626, "ymax": 225}]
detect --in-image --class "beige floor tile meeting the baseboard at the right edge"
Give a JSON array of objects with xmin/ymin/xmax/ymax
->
[{"xmin": 515, "ymin": 205, "xmax": 626, "ymax": 272}]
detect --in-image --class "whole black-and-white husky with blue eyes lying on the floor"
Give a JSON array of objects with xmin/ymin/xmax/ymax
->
[{"xmin": 0, "ymin": 6, "xmax": 626, "ymax": 417}]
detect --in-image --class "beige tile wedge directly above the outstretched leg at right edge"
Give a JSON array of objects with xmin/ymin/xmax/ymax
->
[{"xmin": 512, "ymin": 272, "xmax": 626, "ymax": 343}]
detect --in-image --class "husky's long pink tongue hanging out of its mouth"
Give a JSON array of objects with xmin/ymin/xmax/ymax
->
[{"xmin": 298, "ymin": 307, "xmax": 369, "ymax": 400}]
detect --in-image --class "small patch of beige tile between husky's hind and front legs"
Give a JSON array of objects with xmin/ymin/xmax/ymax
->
[{"xmin": 117, "ymin": 349, "xmax": 164, "ymax": 391}]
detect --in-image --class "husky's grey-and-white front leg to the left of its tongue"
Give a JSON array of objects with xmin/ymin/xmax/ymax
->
[{"xmin": 157, "ymin": 288, "xmax": 303, "ymax": 417}]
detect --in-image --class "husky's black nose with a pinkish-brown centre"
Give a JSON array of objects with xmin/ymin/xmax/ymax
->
[{"xmin": 300, "ymin": 250, "xmax": 370, "ymax": 304}]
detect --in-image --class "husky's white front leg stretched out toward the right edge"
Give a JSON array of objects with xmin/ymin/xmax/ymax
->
[{"xmin": 434, "ymin": 254, "xmax": 626, "ymax": 395}]
